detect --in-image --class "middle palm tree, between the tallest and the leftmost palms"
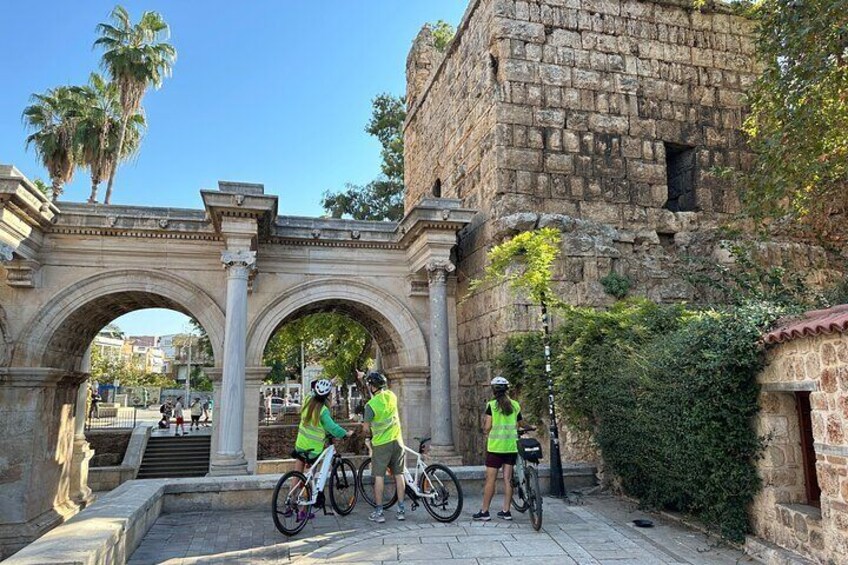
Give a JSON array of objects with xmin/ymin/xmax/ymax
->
[{"xmin": 76, "ymin": 73, "xmax": 145, "ymax": 203}]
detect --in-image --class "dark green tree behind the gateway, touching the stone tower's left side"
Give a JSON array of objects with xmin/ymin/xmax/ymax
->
[{"xmin": 322, "ymin": 93, "xmax": 406, "ymax": 221}]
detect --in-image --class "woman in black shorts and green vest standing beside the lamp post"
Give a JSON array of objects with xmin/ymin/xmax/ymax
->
[{"xmin": 473, "ymin": 376, "xmax": 521, "ymax": 522}]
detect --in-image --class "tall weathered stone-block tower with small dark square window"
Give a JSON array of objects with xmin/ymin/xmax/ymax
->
[{"xmin": 405, "ymin": 0, "xmax": 840, "ymax": 462}]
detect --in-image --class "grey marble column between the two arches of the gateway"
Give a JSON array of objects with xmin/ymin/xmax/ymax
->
[{"xmin": 209, "ymin": 250, "xmax": 256, "ymax": 475}]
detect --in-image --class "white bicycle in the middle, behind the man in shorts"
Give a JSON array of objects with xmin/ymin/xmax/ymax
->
[{"xmin": 357, "ymin": 438, "xmax": 463, "ymax": 522}]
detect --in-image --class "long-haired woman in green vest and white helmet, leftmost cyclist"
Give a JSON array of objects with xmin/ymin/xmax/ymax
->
[{"xmin": 291, "ymin": 379, "xmax": 353, "ymax": 473}]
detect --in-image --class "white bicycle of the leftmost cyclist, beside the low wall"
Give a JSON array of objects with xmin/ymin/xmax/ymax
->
[{"xmin": 271, "ymin": 438, "xmax": 358, "ymax": 536}]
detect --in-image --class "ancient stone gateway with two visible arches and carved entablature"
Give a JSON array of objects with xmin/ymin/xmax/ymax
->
[{"xmin": 0, "ymin": 166, "xmax": 473, "ymax": 550}]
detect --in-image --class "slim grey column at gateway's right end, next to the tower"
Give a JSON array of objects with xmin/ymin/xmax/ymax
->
[{"xmin": 427, "ymin": 260, "xmax": 456, "ymax": 458}]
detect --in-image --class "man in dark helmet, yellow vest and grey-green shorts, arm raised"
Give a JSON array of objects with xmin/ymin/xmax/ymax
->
[{"xmin": 358, "ymin": 372, "xmax": 406, "ymax": 524}]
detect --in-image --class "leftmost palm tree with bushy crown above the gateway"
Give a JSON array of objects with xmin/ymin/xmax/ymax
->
[{"xmin": 23, "ymin": 86, "xmax": 79, "ymax": 201}]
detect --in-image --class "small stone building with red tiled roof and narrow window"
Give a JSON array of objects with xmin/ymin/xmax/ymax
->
[{"xmin": 748, "ymin": 305, "xmax": 848, "ymax": 563}]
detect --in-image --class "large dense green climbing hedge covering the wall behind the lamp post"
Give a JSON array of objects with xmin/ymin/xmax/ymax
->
[{"xmin": 498, "ymin": 300, "xmax": 782, "ymax": 541}]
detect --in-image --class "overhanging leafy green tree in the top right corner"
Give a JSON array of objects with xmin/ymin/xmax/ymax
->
[{"xmin": 740, "ymin": 0, "xmax": 848, "ymax": 240}]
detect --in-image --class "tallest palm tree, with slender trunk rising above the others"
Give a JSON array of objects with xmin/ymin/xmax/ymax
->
[{"xmin": 94, "ymin": 6, "xmax": 177, "ymax": 204}]
